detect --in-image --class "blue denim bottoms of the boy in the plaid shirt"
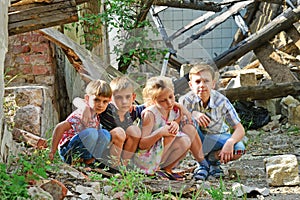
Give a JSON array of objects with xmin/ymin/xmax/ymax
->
[{"xmin": 194, "ymin": 123, "xmax": 245, "ymax": 155}]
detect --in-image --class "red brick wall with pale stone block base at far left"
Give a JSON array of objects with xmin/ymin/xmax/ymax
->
[{"xmin": 4, "ymin": 32, "xmax": 61, "ymax": 137}]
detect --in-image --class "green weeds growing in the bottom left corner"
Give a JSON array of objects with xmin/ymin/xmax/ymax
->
[{"xmin": 0, "ymin": 147, "xmax": 58, "ymax": 200}]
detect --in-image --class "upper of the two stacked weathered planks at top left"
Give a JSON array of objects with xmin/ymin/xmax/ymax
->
[{"xmin": 8, "ymin": 1, "xmax": 77, "ymax": 24}]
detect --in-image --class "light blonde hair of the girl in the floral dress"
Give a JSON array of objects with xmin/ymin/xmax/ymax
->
[{"xmin": 143, "ymin": 76, "xmax": 174, "ymax": 104}]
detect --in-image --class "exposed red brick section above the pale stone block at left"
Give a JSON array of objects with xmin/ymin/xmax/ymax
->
[{"xmin": 5, "ymin": 32, "xmax": 55, "ymax": 90}]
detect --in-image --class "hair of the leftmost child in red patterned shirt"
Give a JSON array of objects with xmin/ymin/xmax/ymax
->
[{"xmin": 85, "ymin": 79, "xmax": 112, "ymax": 98}]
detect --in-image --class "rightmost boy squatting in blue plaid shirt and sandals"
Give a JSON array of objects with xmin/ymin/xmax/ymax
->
[{"xmin": 179, "ymin": 63, "xmax": 245, "ymax": 180}]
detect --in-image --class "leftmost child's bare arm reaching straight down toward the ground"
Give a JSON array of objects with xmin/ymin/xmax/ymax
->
[{"xmin": 49, "ymin": 121, "xmax": 72, "ymax": 160}]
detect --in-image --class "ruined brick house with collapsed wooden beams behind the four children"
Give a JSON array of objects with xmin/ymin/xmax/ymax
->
[{"xmin": 1, "ymin": 0, "xmax": 300, "ymax": 161}]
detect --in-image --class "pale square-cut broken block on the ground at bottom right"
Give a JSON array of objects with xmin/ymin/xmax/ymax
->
[{"xmin": 264, "ymin": 155, "xmax": 300, "ymax": 186}]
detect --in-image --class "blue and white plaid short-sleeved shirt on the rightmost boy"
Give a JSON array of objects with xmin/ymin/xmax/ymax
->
[{"xmin": 179, "ymin": 90, "xmax": 241, "ymax": 134}]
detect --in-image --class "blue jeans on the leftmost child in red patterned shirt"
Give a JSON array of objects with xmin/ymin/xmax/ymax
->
[{"xmin": 59, "ymin": 128, "xmax": 111, "ymax": 164}]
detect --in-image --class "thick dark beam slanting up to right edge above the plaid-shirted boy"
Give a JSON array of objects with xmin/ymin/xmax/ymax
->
[{"xmin": 214, "ymin": 6, "xmax": 300, "ymax": 69}]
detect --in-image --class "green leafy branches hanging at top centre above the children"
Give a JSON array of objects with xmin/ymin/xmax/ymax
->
[{"xmin": 73, "ymin": 0, "xmax": 167, "ymax": 73}]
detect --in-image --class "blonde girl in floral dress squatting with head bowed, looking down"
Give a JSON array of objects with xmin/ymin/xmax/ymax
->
[{"xmin": 135, "ymin": 76, "xmax": 191, "ymax": 179}]
